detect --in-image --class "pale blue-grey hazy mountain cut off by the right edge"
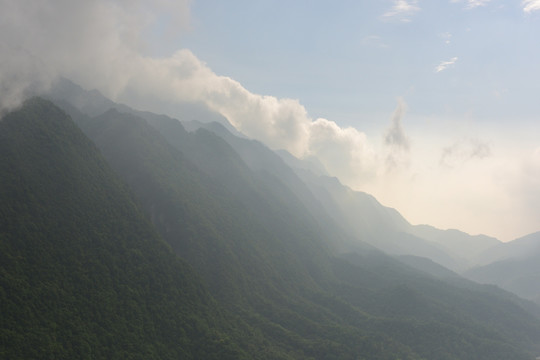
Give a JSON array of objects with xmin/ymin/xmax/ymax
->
[{"xmin": 464, "ymin": 232, "xmax": 540, "ymax": 304}]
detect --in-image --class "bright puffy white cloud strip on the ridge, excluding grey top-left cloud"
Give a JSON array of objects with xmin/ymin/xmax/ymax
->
[{"xmin": 135, "ymin": 50, "xmax": 376, "ymax": 184}]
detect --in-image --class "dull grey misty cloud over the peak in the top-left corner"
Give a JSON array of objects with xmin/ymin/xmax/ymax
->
[{"xmin": 0, "ymin": 0, "xmax": 189, "ymax": 109}]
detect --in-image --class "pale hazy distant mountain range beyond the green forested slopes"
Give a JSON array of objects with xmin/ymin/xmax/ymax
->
[{"xmin": 178, "ymin": 113, "xmax": 540, "ymax": 304}]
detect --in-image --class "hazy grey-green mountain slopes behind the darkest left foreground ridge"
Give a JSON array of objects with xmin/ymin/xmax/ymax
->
[{"xmin": 43, "ymin": 83, "xmax": 540, "ymax": 359}]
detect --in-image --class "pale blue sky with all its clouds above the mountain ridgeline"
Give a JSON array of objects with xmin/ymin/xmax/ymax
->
[{"xmin": 0, "ymin": 0, "xmax": 540, "ymax": 241}]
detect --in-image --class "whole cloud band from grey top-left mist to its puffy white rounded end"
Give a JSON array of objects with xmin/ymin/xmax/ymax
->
[{"xmin": 0, "ymin": 0, "xmax": 380, "ymax": 186}]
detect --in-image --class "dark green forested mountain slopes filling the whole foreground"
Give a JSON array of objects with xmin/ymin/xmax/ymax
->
[{"xmin": 0, "ymin": 90, "xmax": 540, "ymax": 359}]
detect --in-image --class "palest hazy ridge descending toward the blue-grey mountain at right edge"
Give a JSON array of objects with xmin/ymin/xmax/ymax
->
[{"xmin": 284, "ymin": 156, "xmax": 508, "ymax": 273}]
